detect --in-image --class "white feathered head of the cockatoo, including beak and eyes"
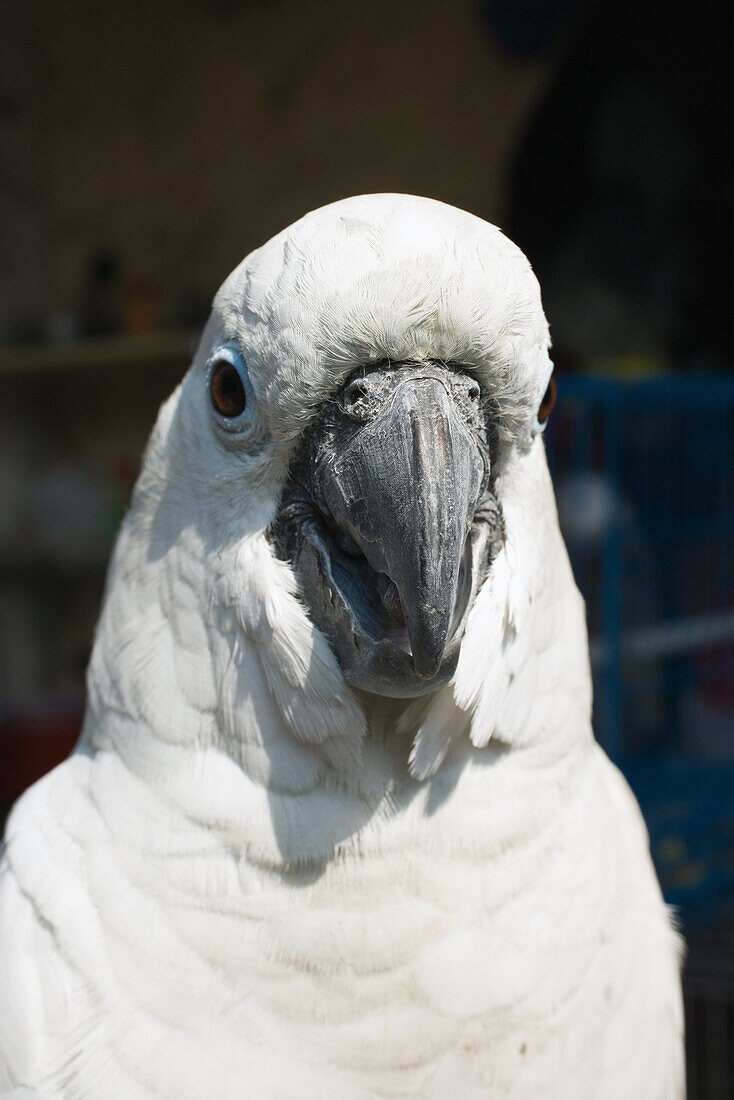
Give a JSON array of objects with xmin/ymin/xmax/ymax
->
[{"xmin": 90, "ymin": 195, "xmax": 589, "ymax": 800}]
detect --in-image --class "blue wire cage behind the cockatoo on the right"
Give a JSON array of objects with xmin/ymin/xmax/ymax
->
[{"xmin": 547, "ymin": 376, "xmax": 734, "ymax": 930}]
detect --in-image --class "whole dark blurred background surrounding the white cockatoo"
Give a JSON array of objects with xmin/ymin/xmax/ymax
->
[{"xmin": 0, "ymin": 0, "xmax": 734, "ymax": 1100}]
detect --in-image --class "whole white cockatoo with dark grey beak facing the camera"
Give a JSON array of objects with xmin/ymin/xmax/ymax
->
[{"xmin": 0, "ymin": 195, "xmax": 684, "ymax": 1100}]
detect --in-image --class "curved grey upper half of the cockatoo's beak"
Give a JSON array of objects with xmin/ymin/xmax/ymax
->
[{"xmin": 321, "ymin": 376, "xmax": 485, "ymax": 680}]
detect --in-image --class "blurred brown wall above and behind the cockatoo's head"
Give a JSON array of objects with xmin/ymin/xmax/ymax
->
[{"xmin": 0, "ymin": 0, "xmax": 551, "ymax": 332}]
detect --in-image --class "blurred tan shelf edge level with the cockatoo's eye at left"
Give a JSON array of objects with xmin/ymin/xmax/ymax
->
[{"xmin": 0, "ymin": 329, "xmax": 199, "ymax": 377}]
